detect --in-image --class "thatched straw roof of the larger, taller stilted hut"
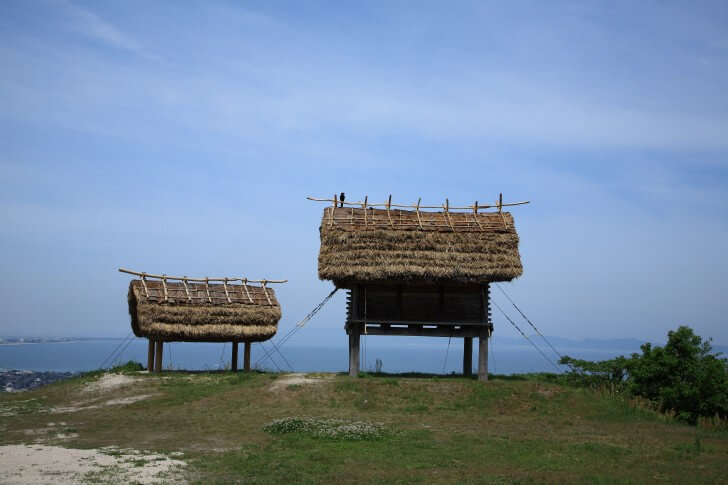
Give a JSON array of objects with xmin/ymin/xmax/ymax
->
[{"xmin": 319, "ymin": 207, "xmax": 523, "ymax": 287}]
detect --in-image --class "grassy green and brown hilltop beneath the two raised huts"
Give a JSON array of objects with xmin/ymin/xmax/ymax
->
[{"xmin": 0, "ymin": 372, "xmax": 728, "ymax": 483}]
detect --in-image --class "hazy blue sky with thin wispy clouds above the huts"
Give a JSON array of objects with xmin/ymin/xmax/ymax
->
[{"xmin": 0, "ymin": 0, "xmax": 728, "ymax": 345}]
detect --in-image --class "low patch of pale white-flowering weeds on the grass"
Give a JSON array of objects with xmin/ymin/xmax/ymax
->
[{"xmin": 263, "ymin": 416, "xmax": 387, "ymax": 441}]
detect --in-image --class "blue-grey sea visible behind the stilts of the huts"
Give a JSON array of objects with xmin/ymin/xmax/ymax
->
[{"xmin": 0, "ymin": 330, "xmax": 663, "ymax": 374}]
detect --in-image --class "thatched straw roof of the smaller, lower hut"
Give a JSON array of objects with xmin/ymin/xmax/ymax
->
[{"xmin": 128, "ymin": 280, "xmax": 281, "ymax": 342}]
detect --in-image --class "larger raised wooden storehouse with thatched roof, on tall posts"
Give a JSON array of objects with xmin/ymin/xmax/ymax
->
[{"xmin": 310, "ymin": 197, "xmax": 523, "ymax": 379}]
